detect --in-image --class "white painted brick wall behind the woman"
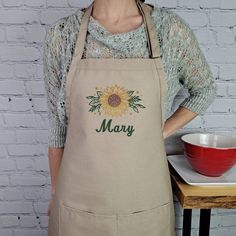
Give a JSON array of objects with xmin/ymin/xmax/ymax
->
[{"xmin": 0, "ymin": 0, "xmax": 236, "ymax": 236}]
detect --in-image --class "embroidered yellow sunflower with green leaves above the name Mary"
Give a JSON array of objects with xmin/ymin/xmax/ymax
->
[{"xmin": 86, "ymin": 85, "xmax": 145, "ymax": 116}]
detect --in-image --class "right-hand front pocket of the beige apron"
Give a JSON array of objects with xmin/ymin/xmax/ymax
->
[{"xmin": 118, "ymin": 202, "xmax": 173, "ymax": 236}]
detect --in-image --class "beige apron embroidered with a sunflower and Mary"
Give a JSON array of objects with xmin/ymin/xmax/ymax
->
[{"xmin": 48, "ymin": 1, "xmax": 175, "ymax": 236}]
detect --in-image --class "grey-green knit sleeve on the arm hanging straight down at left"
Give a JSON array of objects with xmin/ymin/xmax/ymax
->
[{"xmin": 43, "ymin": 24, "xmax": 66, "ymax": 147}]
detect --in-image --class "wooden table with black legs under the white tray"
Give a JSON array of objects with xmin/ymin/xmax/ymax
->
[{"xmin": 168, "ymin": 162, "xmax": 236, "ymax": 236}]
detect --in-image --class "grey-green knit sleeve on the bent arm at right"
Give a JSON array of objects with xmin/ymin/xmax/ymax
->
[{"xmin": 170, "ymin": 13, "xmax": 216, "ymax": 114}]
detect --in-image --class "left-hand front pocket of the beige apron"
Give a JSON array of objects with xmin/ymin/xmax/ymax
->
[{"xmin": 59, "ymin": 202, "xmax": 116, "ymax": 236}]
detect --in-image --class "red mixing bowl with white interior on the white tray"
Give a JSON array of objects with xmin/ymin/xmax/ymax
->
[{"xmin": 181, "ymin": 133, "xmax": 236, "ymax": 177}]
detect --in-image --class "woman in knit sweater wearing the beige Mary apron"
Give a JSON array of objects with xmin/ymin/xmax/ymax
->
[{"xmin": 44, "ymin": 0, "xmax": 216, "ymax": 236}]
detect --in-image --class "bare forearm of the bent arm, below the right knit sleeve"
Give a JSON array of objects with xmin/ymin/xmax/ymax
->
[{"xmin": 162, "ymin": 107, "xmax": 198, "ymax": 139}]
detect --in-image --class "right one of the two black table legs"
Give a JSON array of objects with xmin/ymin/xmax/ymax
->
[{"xmin": 199, "ymin": 209, "xmax": 211, "ymax": 236}]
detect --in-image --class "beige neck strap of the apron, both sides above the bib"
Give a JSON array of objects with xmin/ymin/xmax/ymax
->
[{"xmin": 75, "ymin": 0, "xmax": 161, "ymax": 59}]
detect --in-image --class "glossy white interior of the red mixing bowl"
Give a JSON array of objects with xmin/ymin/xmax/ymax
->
[{"xmin": 181, "ymin": 133, "xmax": 236, "ymax": 149}]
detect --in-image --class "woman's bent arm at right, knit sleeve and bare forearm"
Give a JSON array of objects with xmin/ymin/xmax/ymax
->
[{"xmin": 163, "ymin": 10, "xmax": 216, "ymax": 138}]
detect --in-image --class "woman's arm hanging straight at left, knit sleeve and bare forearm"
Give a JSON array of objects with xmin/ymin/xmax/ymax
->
[{"xmin": 43, "ymin": 22, "xmax": 66, "ymax": 196}]
